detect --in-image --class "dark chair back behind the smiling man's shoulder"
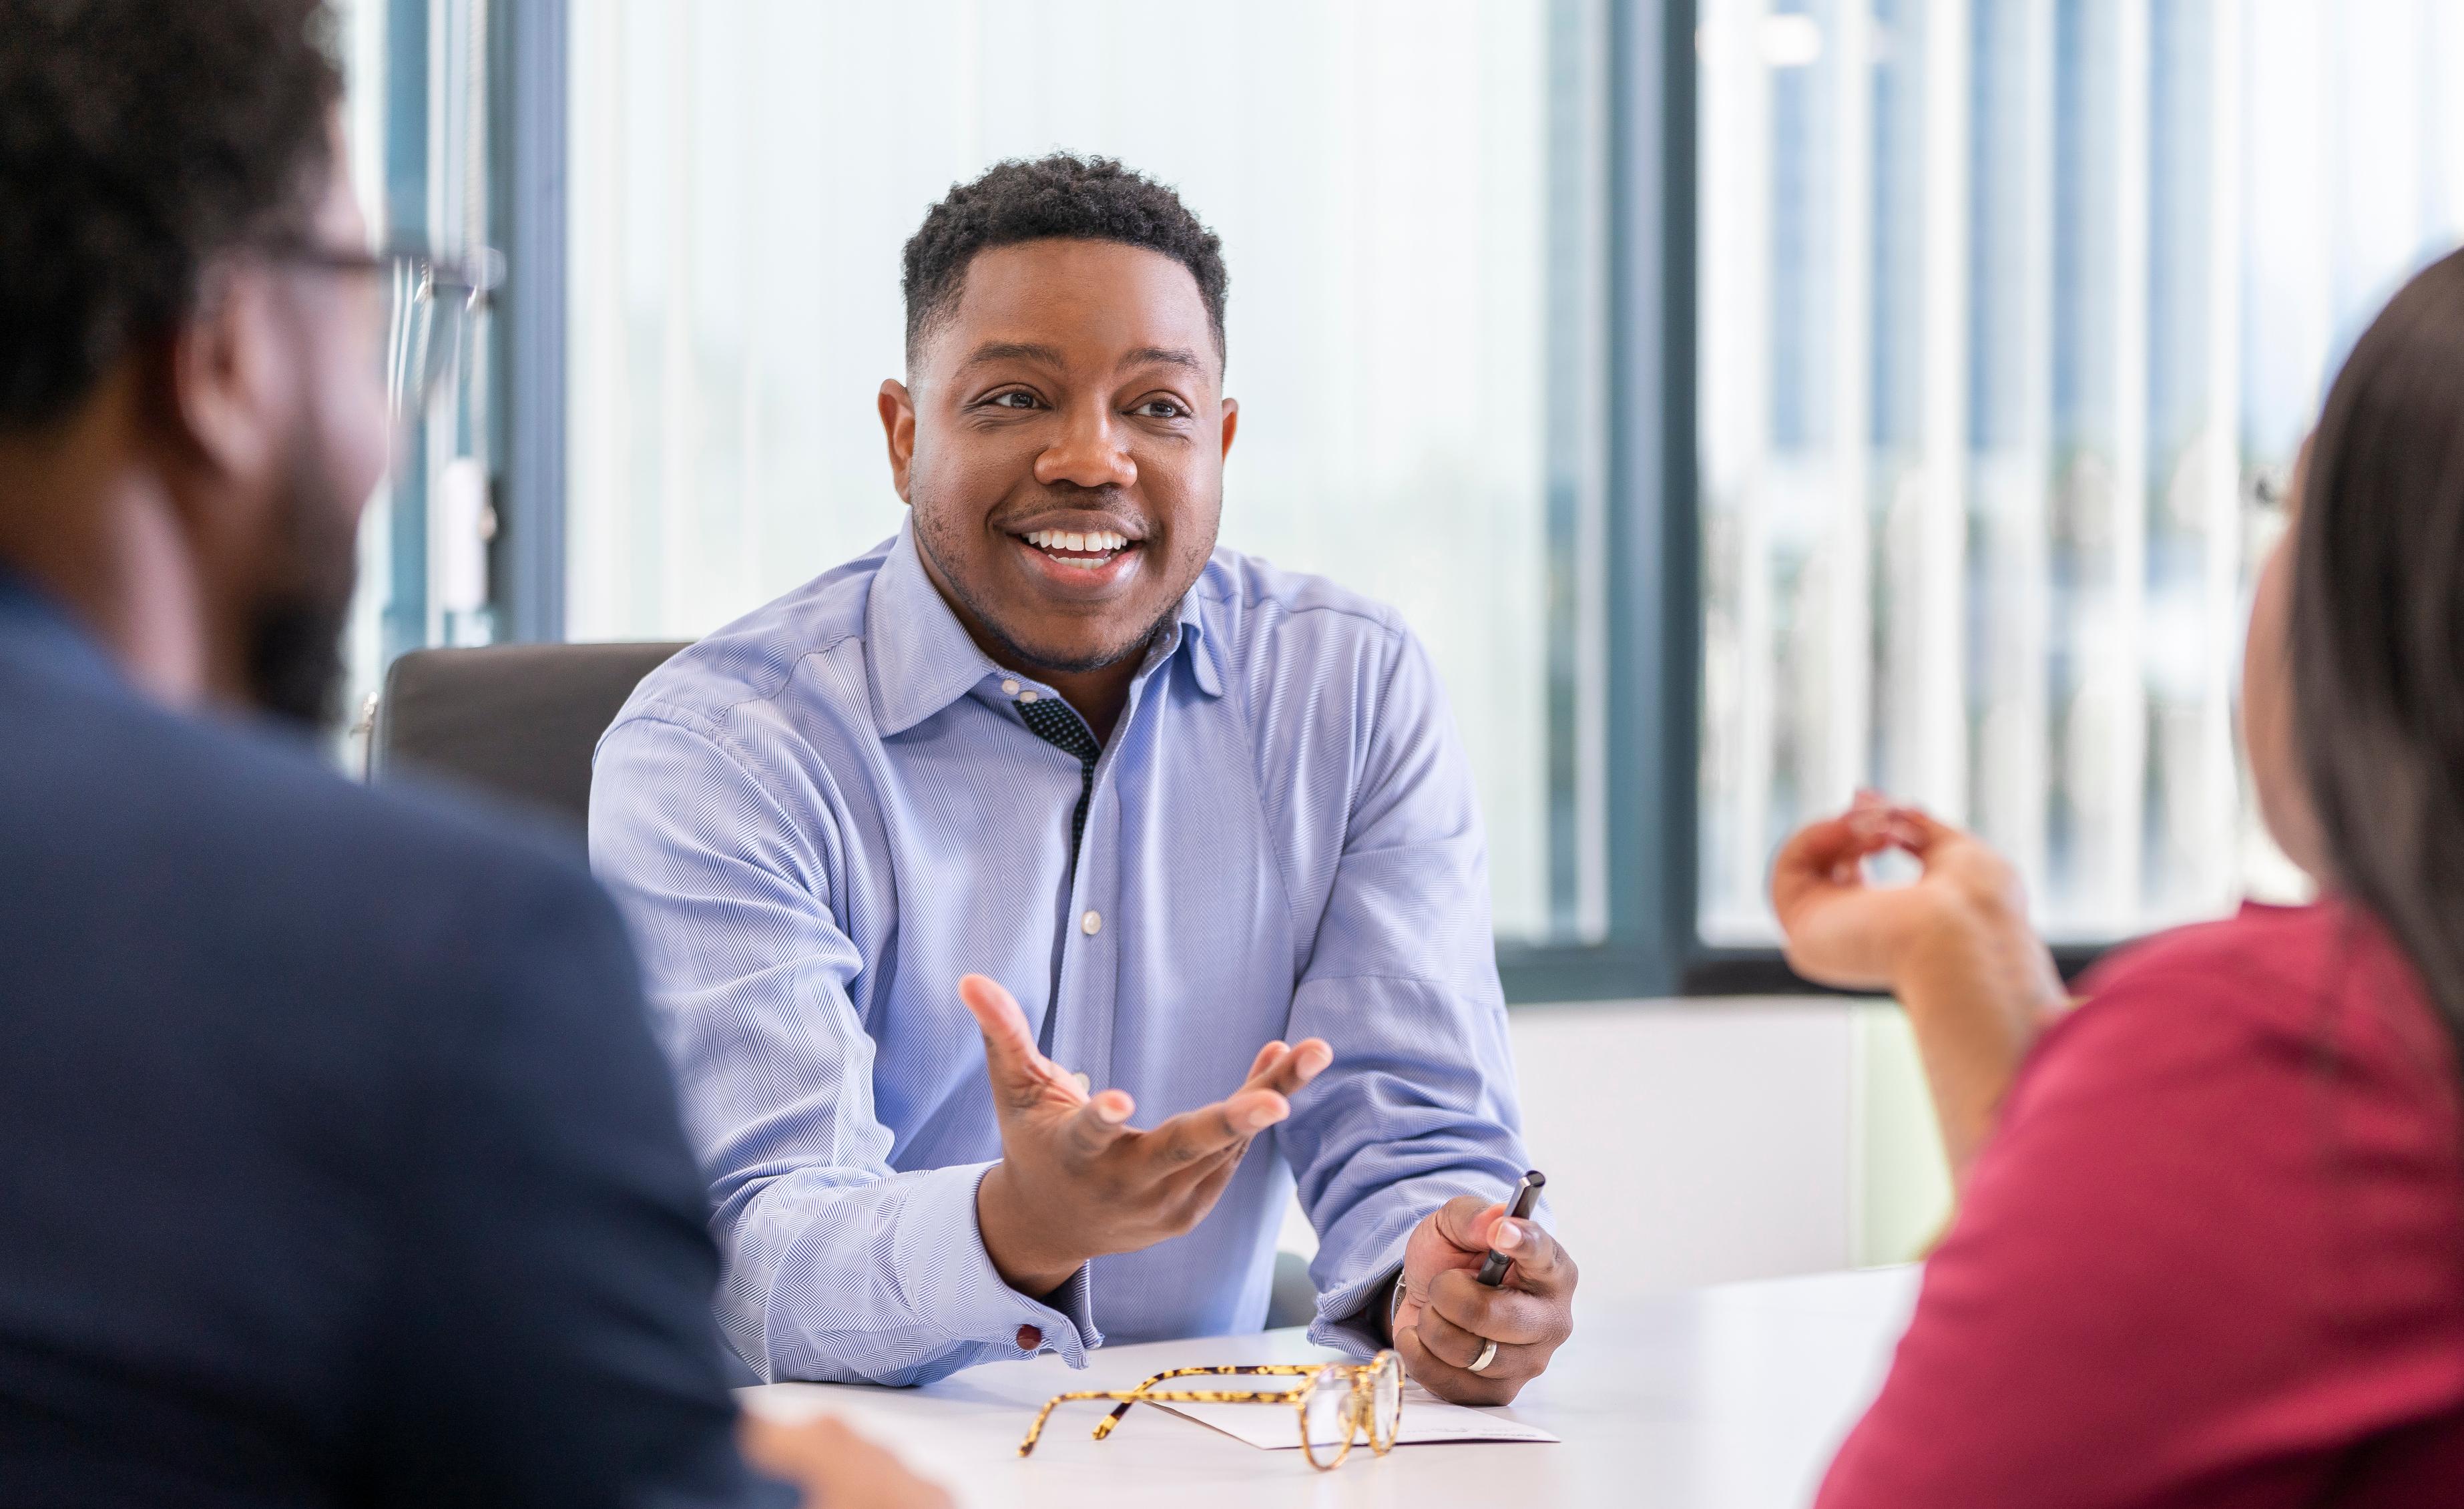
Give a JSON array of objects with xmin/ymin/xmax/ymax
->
[{"xmin": 367, "ymin": 644, "xmax": 685, "ymax": 843}]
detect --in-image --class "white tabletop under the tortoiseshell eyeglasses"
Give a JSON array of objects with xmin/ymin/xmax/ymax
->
[{"xmin": 744, "ymin": 1267, "xmax": 1917, "ymax": 1509}]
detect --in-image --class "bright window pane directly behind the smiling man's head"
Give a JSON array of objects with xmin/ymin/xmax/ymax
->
[{"xmin": 567, "ymin": 0, "xmax": 1607, "ymax": 939}]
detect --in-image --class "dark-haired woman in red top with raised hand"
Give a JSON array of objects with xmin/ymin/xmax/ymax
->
[{"xmin": 1772, "ymin": 254, "xmax": 2464, "ymax": 1509}]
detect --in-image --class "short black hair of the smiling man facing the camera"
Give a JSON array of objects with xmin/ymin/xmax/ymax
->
[{"xmin": 905, "ymin": 153, "xmax": 1230, "ymax": 363}]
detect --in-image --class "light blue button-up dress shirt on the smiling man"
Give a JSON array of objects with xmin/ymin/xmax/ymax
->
[{"xmin": 591, "ymin": 530, "xmax": 1523, "ymax": 1383}]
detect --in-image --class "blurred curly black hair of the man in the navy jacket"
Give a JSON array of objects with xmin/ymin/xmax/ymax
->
[{"xmin": 0, "ymin": 0, "xmax": 342, "ymax": 434}]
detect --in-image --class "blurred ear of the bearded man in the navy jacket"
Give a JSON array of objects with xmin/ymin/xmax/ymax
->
[{"xmin": 165, "ymin": 269, "xmax": 283, "ymax": 485}]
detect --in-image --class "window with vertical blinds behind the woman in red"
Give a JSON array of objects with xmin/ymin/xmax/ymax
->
[{"xmin": 1698, "ymin": 0, "xmax": 2464, "ymax": 942}]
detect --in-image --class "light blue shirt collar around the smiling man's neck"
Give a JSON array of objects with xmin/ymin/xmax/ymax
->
[{"xmin": 865, "ymin": 520, "xmax": 1222, "ymax": 737}]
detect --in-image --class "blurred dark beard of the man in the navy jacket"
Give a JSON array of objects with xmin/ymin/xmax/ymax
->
[{"xmin": 246, "ymin": 439, "xmax": 360, "ymax": 727}]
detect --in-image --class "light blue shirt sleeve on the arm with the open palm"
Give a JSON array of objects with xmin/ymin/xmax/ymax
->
[{"xmin": 591, "ymin": 705, "xmax": 1101, "ymax": 1383}]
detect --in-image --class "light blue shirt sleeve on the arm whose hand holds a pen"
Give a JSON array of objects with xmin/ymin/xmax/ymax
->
[{"xmin": 1279, "ymin": 629, "xmax": 1525, "ymax": 1349}]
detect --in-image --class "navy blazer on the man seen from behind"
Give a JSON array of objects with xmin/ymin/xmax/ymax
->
[{"xmin": 0, "ymin": 574, "xmax": 781, "ymax": 1509}]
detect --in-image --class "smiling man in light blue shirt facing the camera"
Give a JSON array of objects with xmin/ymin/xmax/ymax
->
[{"xmin": 591, "ymin": 158, "xmax": 1575, "ymax": 1403}]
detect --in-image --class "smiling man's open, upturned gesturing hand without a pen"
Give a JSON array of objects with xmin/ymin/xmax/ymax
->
[{"xmin": 959, "ymin": 974, "xmax": 1333, "ymax": 1295}]
